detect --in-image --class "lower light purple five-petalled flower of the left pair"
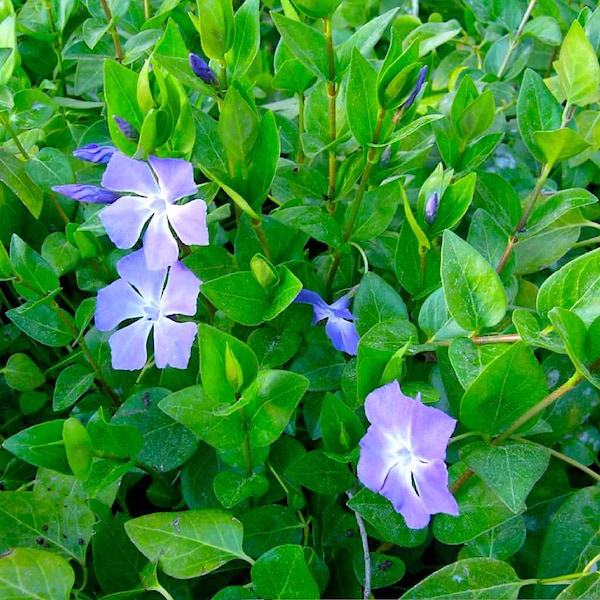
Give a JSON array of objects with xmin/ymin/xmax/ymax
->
[{"xmin": 95, "ymin": 250, "xmax": 200, "ymax": 371}]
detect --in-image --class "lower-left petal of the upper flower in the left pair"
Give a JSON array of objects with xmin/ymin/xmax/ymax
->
[{"xmin": 98, "ymin": 196, "xmax": 153, "ymax": 249}]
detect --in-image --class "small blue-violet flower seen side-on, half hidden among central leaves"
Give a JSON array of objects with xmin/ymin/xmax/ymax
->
[{"xmin": 294, "ymin": 290, "xmax": 358, "ymax": 355}]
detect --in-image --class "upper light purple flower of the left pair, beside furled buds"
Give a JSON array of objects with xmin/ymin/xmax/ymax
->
[{"xmin": 99, "ymin": 152, "xmax": 208, "ymax": 269}]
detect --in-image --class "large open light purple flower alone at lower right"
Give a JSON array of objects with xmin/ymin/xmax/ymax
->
[{"xmin": 358, "ymin": 381, "xmax": 458, "ymax": 529}]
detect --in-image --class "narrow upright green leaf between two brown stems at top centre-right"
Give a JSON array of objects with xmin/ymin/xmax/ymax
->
[{"xmin": 346, "ymin": 48, "xmax": 379, "ymax": 147}]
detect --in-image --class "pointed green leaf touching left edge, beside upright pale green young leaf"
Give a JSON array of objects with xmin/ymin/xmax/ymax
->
[{"xmin": 2, "ymin": 419, "xmax": 71, "ymax": 475}]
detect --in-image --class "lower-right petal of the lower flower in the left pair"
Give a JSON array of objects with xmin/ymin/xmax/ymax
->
[{"xmin": 154, "ymin": 317, "xmax": 198, "ymax": 369}]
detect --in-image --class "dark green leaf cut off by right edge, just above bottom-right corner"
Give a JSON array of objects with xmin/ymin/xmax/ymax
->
[{"xmin": 537, "ymin": 487, "xmax": 600, "ymax": 597}]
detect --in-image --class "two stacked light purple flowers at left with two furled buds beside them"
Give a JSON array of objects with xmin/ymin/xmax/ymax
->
[{"xmin": 53, "ymin": 144, "xmax": 208, "ymax": 370}]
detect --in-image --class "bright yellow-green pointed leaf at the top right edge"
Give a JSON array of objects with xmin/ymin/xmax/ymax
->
[{"xmin": 554, "ymin": 19, "xmax": 600, "ymax": 106}]
